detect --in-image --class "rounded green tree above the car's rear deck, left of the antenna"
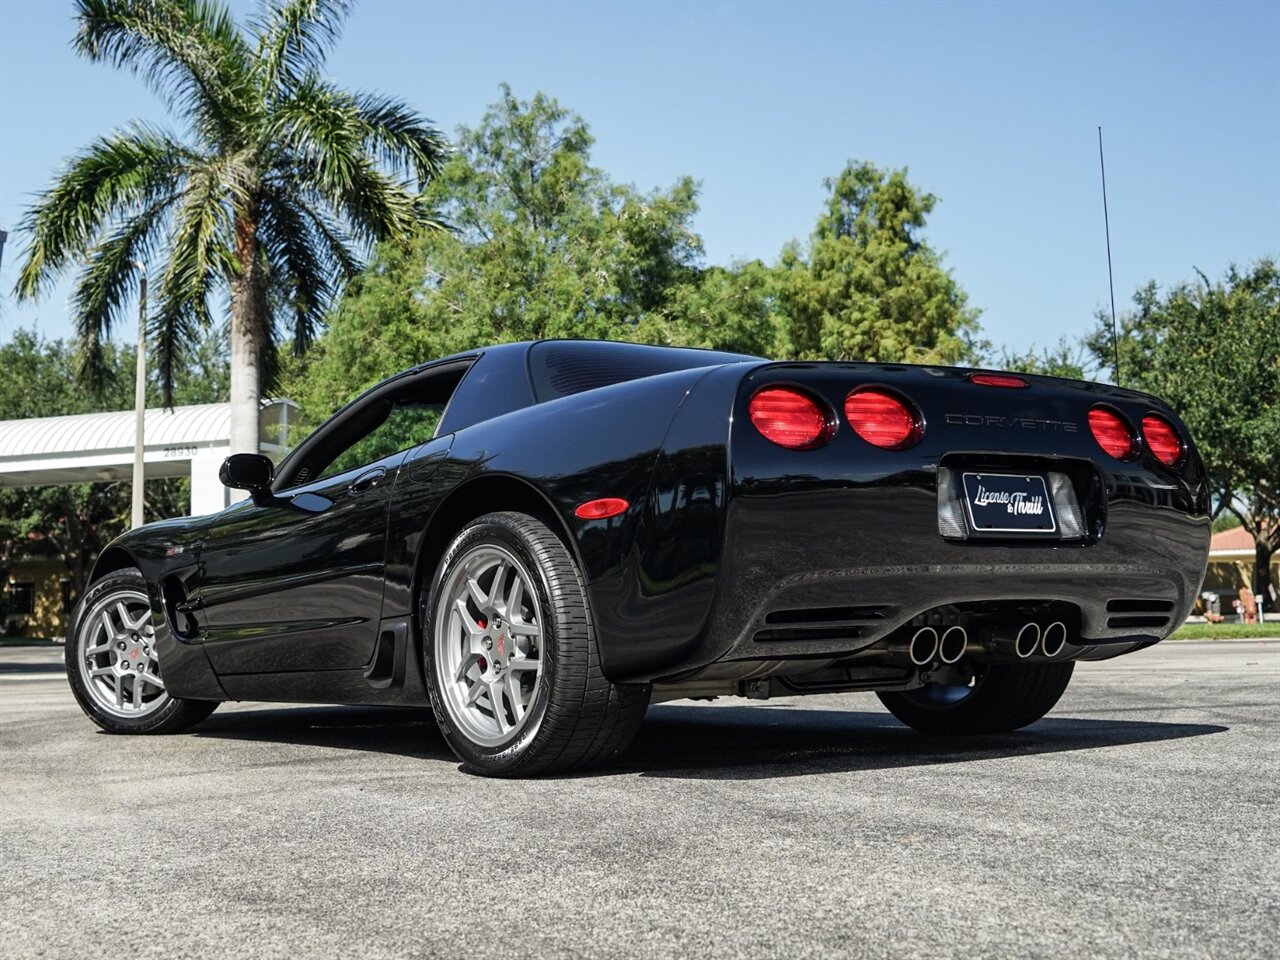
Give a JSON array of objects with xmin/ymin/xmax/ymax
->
[{"xmin": 778, "ymin": 163, "xmax": 978, "ymax": 364}]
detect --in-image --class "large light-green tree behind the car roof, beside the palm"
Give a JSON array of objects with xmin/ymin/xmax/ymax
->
[{"xmin": 285, "ymin": 86, "xmax": 701, "ymax": 420}]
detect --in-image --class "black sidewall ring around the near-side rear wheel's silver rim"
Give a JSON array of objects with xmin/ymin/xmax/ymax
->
[{"xmin": 422, "ymin": 516, "xmax": 559, "ymax": 776}]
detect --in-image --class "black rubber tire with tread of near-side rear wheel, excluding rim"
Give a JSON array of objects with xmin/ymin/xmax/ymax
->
[{"xmin": 421, "ymin": 513, "xmax": 650, "ymax": 777}]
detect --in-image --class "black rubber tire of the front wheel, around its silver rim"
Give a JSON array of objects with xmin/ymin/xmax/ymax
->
[{"xmin": 63, "ymin": 567, "xmax": 218, "ymax": 733}]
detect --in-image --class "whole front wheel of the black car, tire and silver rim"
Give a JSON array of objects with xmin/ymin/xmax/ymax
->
[{"xmin": 64, "ymin": 568, "xmax": 218, "ymax": 733}]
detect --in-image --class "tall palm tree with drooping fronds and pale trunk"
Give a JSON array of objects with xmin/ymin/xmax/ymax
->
[{"xmin": 17, "ymin": 0, "xmax": 447, "ymax": 452}]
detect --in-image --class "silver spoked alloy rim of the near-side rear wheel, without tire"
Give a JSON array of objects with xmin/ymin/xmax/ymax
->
[{"xmin": 433, "ymin": 544, "xmax": 543, "ymax": 748}]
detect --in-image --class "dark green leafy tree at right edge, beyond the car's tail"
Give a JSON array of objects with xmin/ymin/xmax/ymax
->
[{"xmin": 1088, "ymin": 259, "xmax": 1280, "ymax": 598}]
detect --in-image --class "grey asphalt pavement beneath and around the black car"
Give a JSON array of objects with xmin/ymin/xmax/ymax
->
[{"xmin": 0, "ymin": 640, "xmax": 1280, "ymax": 960}]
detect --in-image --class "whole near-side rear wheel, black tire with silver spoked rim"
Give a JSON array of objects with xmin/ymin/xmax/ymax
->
[{"xmin": 422, "ymin": 513, "xmax": 649, "ymax": 777}]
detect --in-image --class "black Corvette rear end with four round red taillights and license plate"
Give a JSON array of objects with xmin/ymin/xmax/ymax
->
[{"xmin": 686, "ymin": 364, "xmax": 1210, "ymax": 686}]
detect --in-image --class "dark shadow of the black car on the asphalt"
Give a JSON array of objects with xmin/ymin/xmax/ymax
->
[{"xmin": 186, "ymin": 704, "xmax": 1228, "ymax": 780}]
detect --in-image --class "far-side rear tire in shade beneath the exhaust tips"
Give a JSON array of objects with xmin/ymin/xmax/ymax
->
[{"xmin": 876, "ymin": 660, "xmax": 1075, "ymax": 736}]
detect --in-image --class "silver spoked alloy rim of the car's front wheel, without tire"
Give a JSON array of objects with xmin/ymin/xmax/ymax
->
[{"xmin": 76, "ymin": 590, "xmax": 169, "ymax": 719}]
